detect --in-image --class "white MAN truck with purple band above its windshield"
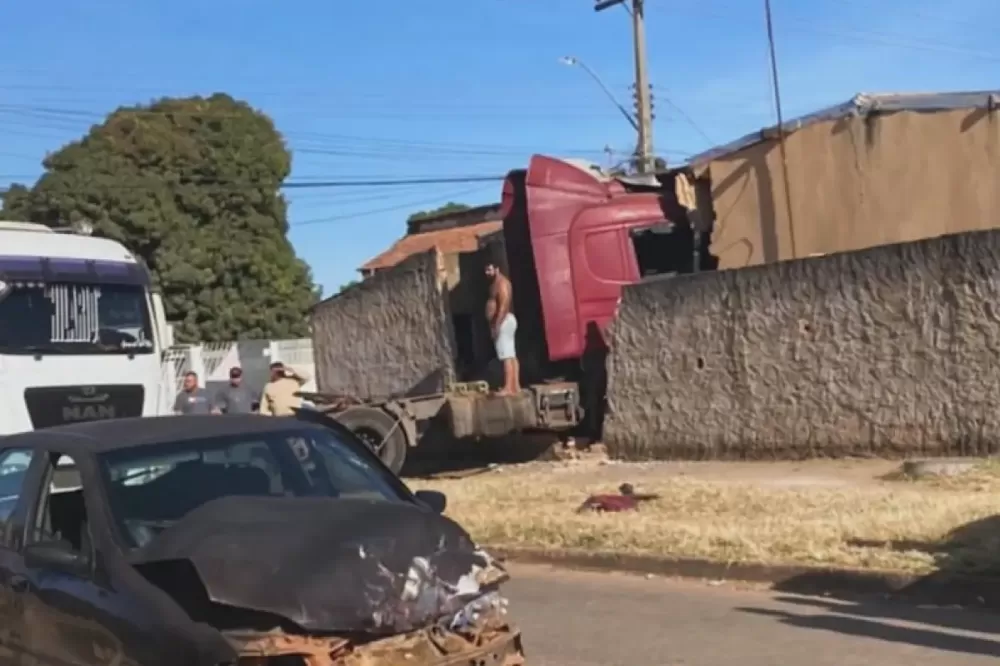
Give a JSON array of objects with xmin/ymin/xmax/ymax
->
[{"xmin": 0, "ymin": 221, "xmax": 173, "ymax": 435}]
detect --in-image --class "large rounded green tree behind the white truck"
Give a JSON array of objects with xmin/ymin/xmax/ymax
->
[{"xmin": 3, "ymin": 94, "xmax": 319, "ymax": 342}]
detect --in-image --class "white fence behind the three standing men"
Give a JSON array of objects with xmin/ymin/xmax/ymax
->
[{"xmin": 163, "ymin": 338, "xmax": 316, "ymax": 395}]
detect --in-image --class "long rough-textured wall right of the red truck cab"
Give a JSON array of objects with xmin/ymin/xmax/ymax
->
[{"xmin": 605, "ymin": 231, "xmax": 1000, "ymax": 459}]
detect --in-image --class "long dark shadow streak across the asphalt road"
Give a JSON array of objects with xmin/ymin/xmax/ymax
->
[{"xmin": 738, "ymin": 598, "xmax": 1000, "ymax": 657}]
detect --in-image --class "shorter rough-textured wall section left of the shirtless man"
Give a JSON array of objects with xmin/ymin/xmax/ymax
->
[{"xmin": 312, "ymin": 252, "xmax": 454, "ymax": 399}]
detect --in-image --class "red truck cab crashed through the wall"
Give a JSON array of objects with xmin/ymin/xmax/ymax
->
[{"xmin": 501, "ymin": 155, "xmax": 692, "ymax": 363}]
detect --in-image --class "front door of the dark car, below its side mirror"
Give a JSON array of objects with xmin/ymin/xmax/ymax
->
[{"xmin": 22, "ymin": 451, "xmax": 154, "ymax": 666}]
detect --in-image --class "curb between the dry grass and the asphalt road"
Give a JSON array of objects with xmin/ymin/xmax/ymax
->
[{"xmin": 485, "ymin": 545, "xmax": 1000, "ymax": 610}]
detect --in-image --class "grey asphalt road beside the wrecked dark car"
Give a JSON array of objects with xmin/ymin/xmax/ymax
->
[{"xmin": 507, "ymin": 565, "xmax": 1000, "ymax": 666}]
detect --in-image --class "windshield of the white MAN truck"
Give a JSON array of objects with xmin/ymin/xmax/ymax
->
[{"xmin": 0, "ymin": 277, "xmax": 154, "ymax": 354}]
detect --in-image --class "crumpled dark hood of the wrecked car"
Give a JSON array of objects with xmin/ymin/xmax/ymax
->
[{"xmin": 129, "ymin": 497, "xmax": 506, "ymax": 634}]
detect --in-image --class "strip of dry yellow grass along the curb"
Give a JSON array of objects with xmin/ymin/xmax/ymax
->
[{"xmin": 410, "ymin": 465, "xmax": 1000, "ymax": 573}]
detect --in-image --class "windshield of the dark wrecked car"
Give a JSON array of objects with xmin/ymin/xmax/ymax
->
[{"xmin": 99, "ymin": 427, "xmax": 411, "ymax": 548}]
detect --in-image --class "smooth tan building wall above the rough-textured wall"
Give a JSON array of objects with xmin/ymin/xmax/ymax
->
[{"xmin": 703, "ymin": 109, "xmax": 1000, "ymax": 268}]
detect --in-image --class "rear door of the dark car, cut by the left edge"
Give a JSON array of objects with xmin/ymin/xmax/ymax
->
[{"xmin": 0, "ymin": 448, "xmax": 34, "ymax": 665}]
